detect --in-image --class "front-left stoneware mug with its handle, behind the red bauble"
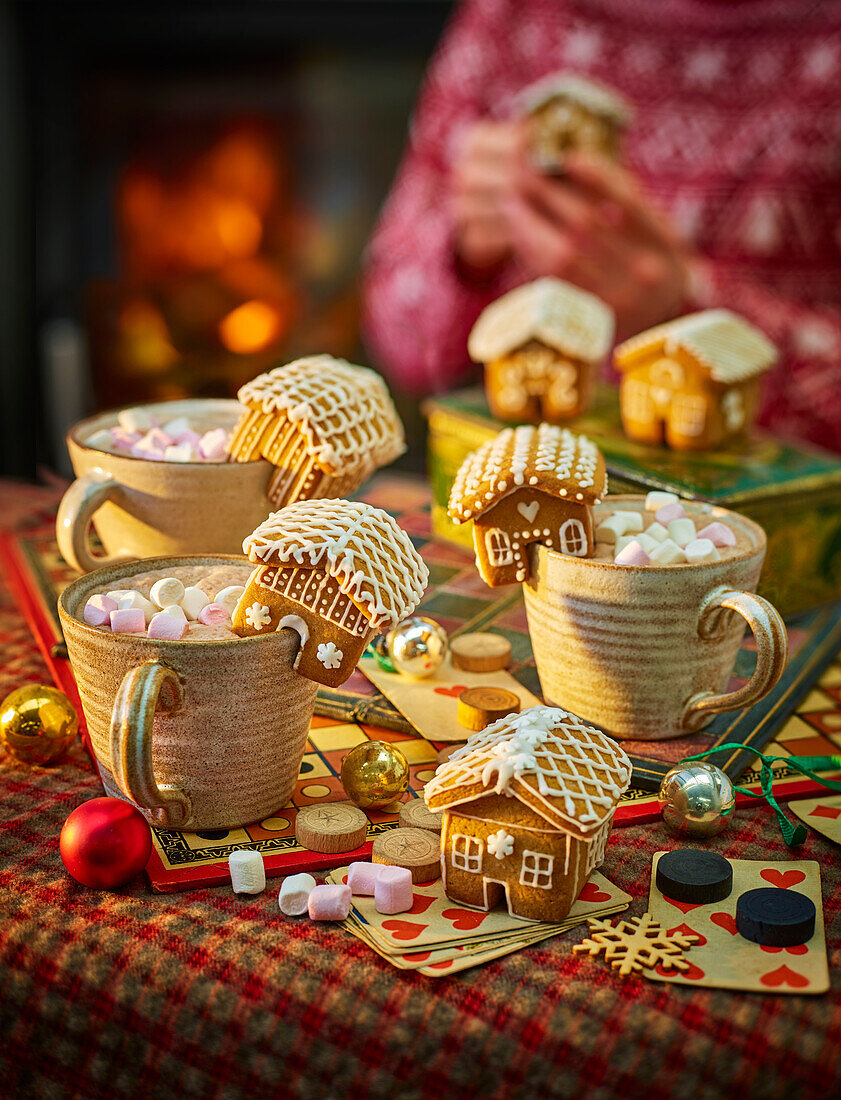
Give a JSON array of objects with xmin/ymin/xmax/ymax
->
[{"xmin": 58, "ymin": 556, "xmax": 317, "ymax": 829}]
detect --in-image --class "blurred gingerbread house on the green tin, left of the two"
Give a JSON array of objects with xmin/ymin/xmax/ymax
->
[{"xmin": 467, "ymin": 276, "xmax": 613, "ymax": 422}]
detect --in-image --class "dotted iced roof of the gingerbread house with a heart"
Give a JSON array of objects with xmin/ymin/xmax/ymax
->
[{"xmin": 447, "ymin": 424, "xmax": 607, "ymax": 524}]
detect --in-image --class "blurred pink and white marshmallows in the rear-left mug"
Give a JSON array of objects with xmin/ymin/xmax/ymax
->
[{"xmin": 85, "ymin": 409, "xmax": 231, "ymax": 462}]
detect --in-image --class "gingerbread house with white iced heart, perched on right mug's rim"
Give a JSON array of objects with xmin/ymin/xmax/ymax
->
[{"xmin": 447, "ymin": 424, "xmax": 607, "ymax": 587}]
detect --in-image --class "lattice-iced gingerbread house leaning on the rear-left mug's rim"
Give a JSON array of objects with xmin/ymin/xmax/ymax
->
[{"xmin": 230, "ymin": 355, "xmax": 406, "ymax": 507}]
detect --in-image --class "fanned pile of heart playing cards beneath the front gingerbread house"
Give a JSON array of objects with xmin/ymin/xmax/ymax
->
[{"xmin": 327, "ymin": 867, "xmax": 631, "ymax": 955}]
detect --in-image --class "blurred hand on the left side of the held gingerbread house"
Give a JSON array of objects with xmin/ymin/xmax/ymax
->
[{"xmin": 451, "ymin": 121, "xmax": 525, "ymax": 273}]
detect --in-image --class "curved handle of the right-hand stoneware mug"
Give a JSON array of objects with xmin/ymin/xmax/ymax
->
[{"xmin": 683, "ymin": 585, "xmax": 788, "ymax": 730}]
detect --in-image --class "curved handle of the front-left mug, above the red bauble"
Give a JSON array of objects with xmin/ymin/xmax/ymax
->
[{"xmin": 110, "ymin": 661, "xmax": 192, "ymax": 828}]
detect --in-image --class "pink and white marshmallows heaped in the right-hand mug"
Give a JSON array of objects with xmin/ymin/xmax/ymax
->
[{"xmin": 596, "ymin": 493, "xmax": 735, "ymax": 565}]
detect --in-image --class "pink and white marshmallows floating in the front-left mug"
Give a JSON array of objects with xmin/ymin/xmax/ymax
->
[{"xmin": 82, "ymin": 576, "xmax": 245, "ymax": 641}]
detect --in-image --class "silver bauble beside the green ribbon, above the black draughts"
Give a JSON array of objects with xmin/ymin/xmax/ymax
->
[{"xmin": 657, "ymin": 760, "xmax": 735, "ymax": 836}]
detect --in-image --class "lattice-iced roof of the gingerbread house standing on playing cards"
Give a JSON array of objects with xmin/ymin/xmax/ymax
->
[{"xmin": 423, "ymin": 706, "xmax": 631, "ymax": 837}]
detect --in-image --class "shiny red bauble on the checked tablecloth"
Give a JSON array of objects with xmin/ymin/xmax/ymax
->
[{"xmin": 58, "ymin": 799, "xmax": 152, "ymax": 890}]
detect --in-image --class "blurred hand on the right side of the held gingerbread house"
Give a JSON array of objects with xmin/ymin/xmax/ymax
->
[{"xmin": 502, "ymin": 153, "xmax": 688, "ymax": 339}]
